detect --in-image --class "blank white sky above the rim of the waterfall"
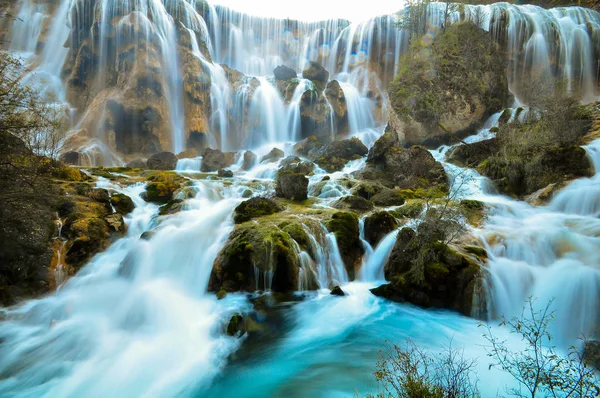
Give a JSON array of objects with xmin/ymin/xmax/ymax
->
[{"xmin": 208, "ymin": 0, "xmax": 403, "ymax": 22}]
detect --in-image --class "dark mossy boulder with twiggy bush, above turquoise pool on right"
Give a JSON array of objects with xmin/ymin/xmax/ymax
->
[{"xmin": 371, "ymin": 228, "xmax": 487, "ymax": 316}]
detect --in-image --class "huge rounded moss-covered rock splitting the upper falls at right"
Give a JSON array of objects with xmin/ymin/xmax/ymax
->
[{"xmin": 389, "ymin": 22, "xmax": 509, "ymax": 147}]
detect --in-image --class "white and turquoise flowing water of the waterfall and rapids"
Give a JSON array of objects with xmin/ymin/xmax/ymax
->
[{"xmin": 0, "ymin": 0, "xmax": 600, "ymax": 397}]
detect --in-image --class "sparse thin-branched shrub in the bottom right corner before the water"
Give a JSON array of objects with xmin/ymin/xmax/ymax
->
[{"xmin": 484, "ymin": 298, "xmax": 600, "ymax": 398}]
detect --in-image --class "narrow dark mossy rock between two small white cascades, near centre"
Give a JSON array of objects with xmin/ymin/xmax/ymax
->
[{"xmin": 325, "ymin": 211, "xmax": 364, "ymax": 280}]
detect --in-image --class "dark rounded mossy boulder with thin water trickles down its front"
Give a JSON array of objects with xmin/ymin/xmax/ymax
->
[{"xmin": 209, "ymin": 222, "xmax": 300, "ymax": 292}]
